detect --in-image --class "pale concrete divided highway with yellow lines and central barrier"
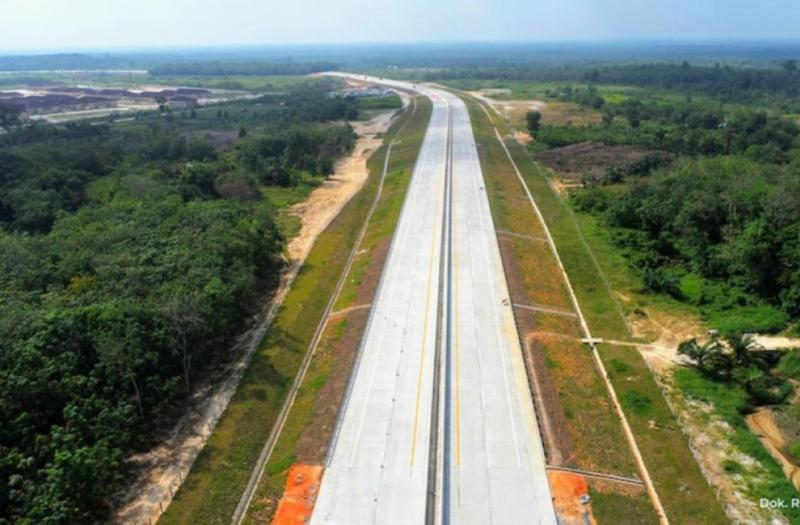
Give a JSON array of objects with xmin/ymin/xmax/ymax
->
[{"xmin": 311, "ymin": 76, "xmax": 556, "ymax": 525}]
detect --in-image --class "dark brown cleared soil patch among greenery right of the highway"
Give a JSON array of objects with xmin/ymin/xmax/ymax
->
[{"xmin": 536, "ymin": 142, "xmax": 658, "ymax": 179}]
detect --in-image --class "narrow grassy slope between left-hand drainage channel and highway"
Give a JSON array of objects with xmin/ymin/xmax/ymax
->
[{"xmin": 244, "ymin": 97, "xmax": 431, "ymax": 524}]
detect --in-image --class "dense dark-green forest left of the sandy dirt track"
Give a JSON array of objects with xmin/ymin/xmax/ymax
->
[{"xmin": 0, "ymin": 81, "xmax": 358, "ymax": 525}]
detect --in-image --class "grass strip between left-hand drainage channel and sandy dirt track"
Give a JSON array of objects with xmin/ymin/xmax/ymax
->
[{"xmin": 159, "ymin": 96, "xmax": 432, "ymax": 525}]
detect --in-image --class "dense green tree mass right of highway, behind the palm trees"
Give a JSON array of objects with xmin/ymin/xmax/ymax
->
[{"xmin": 574, "ymin": 156, "xmax": 800, "ymax": 332}]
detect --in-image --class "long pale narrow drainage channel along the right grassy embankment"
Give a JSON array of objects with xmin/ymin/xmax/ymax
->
[{"xmin": 466, "ymin": 94, "xmax": 669, "ymax": 524}]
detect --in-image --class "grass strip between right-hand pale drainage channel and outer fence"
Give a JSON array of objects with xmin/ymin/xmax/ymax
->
[{"xmin": 460, "ymin": 94, "xmax": 727, "ymax": 524}]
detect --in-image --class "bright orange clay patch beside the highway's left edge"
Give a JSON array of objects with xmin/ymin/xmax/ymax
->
[{"xmin": 272, "ymin": 463, "xmax": 323, "ymax": 525}]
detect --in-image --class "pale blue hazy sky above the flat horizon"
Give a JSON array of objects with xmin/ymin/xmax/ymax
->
[{"xmin": 0, "ymin": 0, "xmax": 800, "ymax": 50}]
